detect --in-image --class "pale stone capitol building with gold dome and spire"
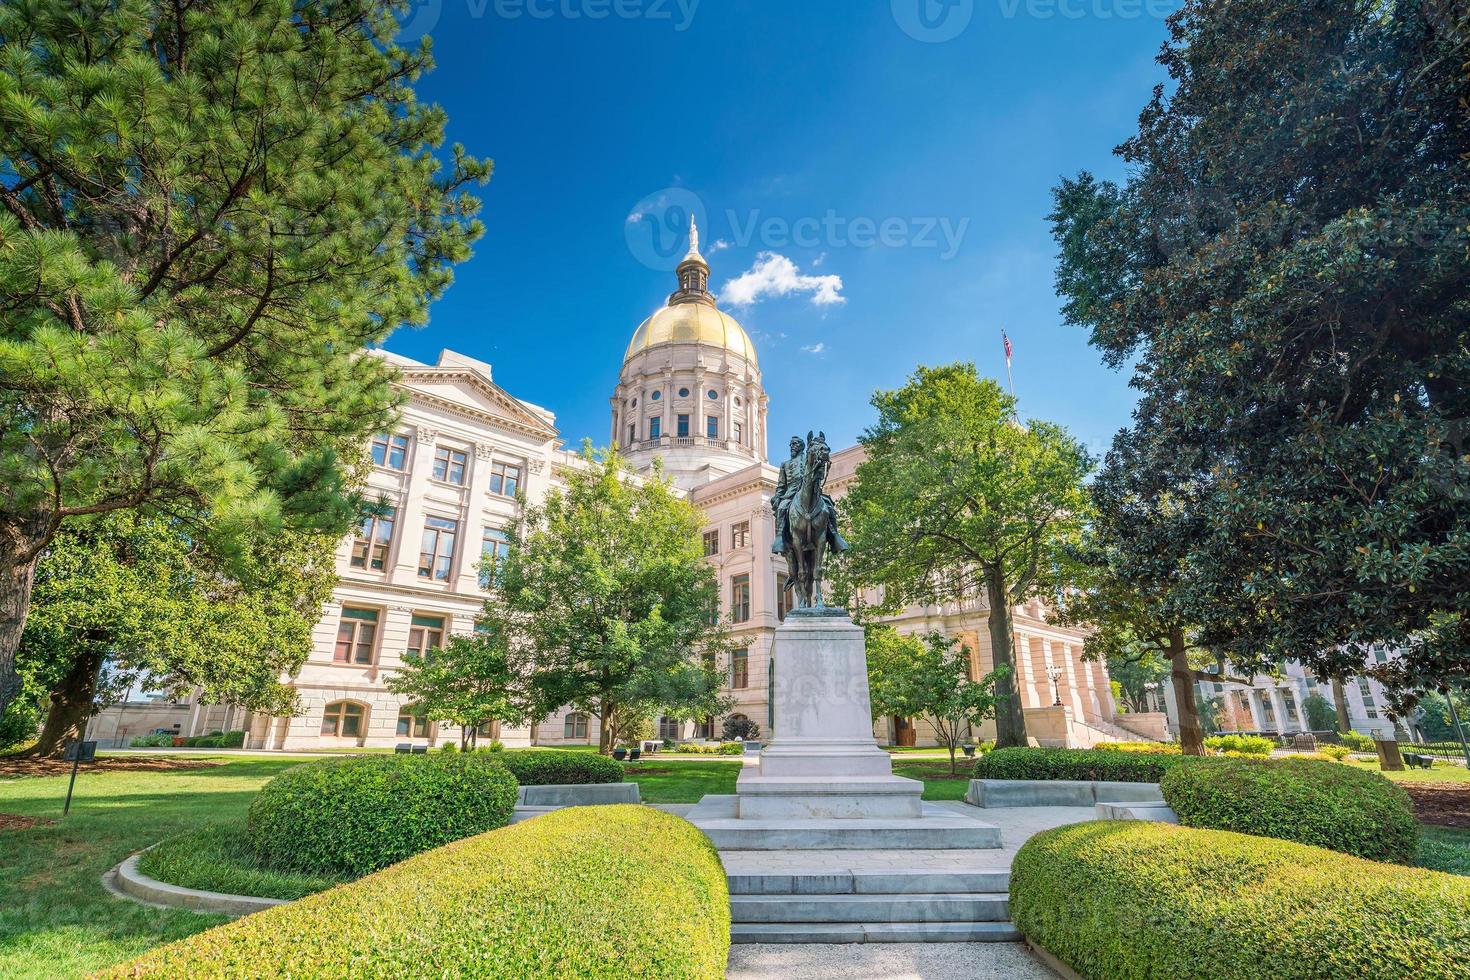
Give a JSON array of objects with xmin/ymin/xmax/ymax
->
[{"xmin": 96, "ymin": 229, "xmax": 1128, "ymax": 749}]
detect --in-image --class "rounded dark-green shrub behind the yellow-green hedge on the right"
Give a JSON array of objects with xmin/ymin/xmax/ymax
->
[{"xmin": 1160, "ymin": 758, "xmax": 1419, "ymax": 862}]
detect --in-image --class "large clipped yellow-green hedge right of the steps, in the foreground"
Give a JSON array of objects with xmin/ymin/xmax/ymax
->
[{"xmin": 1010, "ymin": 822, "xmax": 1470, "ymax": 980}]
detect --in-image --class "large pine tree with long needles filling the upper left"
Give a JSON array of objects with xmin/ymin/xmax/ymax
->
[{"xmin": 0, "ymin": 0, "xmax": 488, "ymax": 713}]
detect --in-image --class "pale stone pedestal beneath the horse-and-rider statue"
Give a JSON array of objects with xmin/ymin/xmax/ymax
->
[{"xmin": 736, "ymin": 610, "xmax": 923, "ymax": 820}]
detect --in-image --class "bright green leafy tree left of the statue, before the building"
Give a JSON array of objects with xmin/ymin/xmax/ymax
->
[{"xmin": 482, "ymin": 445, "xmax": 729, "ymax": 752}]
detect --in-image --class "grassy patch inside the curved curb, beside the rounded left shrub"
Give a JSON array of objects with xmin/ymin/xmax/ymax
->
[{"xmin": 138, "ymin": 820, "xmax": 350, "ymax": 899}]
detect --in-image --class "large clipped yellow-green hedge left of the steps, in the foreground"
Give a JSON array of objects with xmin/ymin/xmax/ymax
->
[{"xmin": 103, "ymin": 805, "xmax": 729, "ymax": 980}]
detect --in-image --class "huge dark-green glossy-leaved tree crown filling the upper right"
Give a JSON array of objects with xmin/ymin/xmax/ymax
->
[{"xmin": 1053, "ymin": 0, "xmax": 1470, "ymax": 692}]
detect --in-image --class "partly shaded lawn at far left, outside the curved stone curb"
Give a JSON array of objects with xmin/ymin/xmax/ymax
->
[{"xmin": 0, "ymin": 754, "xmax": 301, "ymax": 980}]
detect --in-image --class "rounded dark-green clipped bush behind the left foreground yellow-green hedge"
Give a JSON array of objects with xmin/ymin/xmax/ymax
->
[{"xmin": 245, "ymin": 752, "xmax": 516, "ymax": 874}]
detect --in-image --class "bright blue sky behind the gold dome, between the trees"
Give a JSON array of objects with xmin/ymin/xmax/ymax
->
[{"xmin": 387, "ymin": 0, "xmax": 1176, "ymax": 453}]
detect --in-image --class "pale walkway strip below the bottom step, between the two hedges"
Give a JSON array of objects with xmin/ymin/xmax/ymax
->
[{"xmin": 725, "ymin": 943, "xmax": 1055, "ymax": 980}]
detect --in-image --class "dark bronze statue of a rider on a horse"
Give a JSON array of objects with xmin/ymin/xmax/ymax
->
[{"xmin": 770, "ymin": 432, "xmax": 847, "ymax": 610}]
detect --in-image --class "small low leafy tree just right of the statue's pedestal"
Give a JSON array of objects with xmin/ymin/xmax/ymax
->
[{"xmin": 866, "ymin": 626, "xmax": 1004, "ymax": 774}]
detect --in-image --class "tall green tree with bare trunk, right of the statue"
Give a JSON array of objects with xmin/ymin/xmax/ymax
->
[{"xmin": 833, "ymin": 364, "xmax": 1092, "ymax": 745}]
